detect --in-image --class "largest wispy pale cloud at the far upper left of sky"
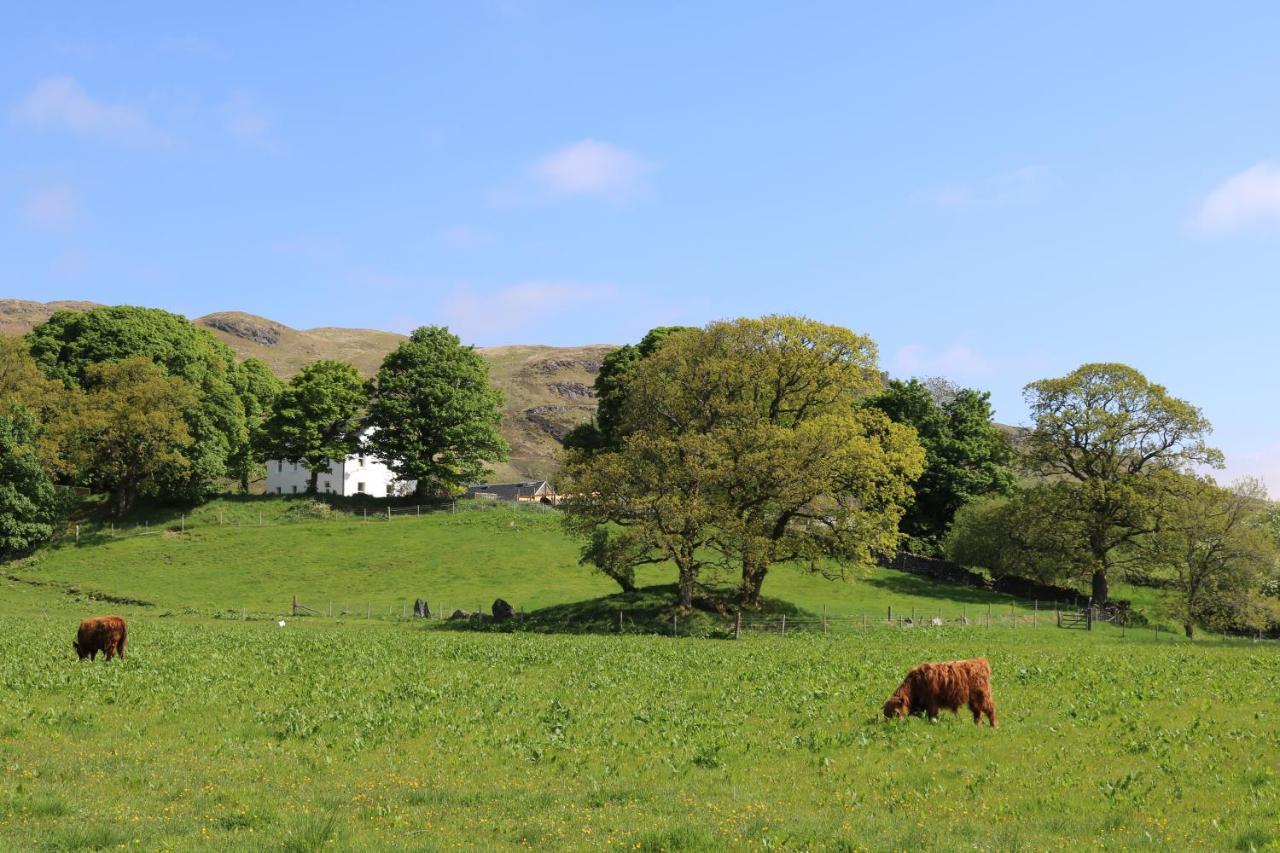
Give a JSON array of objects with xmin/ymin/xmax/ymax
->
[{"xmin": 12, "ymin": 77, "xmax": 173, "ymax": 147}]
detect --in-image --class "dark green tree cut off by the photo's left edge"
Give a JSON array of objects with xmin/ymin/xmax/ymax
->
[{"xmin": 0, "ymin": 400, "xmax": 59, "ymax": 560}]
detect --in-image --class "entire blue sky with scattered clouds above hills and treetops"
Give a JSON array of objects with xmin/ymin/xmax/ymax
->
[{"xmin": 0, "ymin": 0, "xmax": 1280, "ymax": 492}]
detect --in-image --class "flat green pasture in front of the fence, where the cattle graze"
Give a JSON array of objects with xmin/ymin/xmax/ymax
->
[{"xmin": 0, "ymin": 615, "xmax": 1280, "ymax": 850}]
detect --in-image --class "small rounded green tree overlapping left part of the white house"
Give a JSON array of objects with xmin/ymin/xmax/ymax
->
[{"xmin": 259, "ymin": 360, "xmax": 366, "ymax": 494}]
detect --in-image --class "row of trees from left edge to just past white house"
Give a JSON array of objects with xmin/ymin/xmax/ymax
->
[{"xmin": 0, "ymin": 306, "xmax": 507, "ymax": 556}]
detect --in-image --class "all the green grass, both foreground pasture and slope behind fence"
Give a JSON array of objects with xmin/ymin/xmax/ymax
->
[{"xmin": 0, "ymin": 500, "xmax": 1280, "ymax": 850}]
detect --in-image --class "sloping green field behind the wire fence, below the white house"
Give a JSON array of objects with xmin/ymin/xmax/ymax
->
[{"xmin": 6, "ymin": 498, "xmax": 1126, "ymax": 621}]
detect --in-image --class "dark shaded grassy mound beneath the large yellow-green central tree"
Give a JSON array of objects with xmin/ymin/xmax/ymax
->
[{"xmin": 444, "ymin": 584, "xmax": 814, "ymax": 637}]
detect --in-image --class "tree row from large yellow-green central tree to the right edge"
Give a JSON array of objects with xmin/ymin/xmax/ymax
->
[{"xmin": 561, "ymin": 325, "xmax": 1280, "ymax": 634}]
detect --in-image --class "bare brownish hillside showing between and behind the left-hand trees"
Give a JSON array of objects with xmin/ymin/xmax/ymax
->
[{"xmin": 0, "ymin": 300, "xmax": 613, "ymax": 480}]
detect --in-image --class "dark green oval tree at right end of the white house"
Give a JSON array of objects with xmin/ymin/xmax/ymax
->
[{"xmin": 369, "ymin": 325, "xmax": 509, "ymax": 496}]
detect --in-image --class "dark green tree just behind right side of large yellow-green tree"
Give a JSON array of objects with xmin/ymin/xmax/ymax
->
[{"xmin": 868, "ymin": 379, "xmax": 1015, "ymax": 555}]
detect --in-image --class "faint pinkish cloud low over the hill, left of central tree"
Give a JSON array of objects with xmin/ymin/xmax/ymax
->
[{"xmin": 444, "ymin": 282, "xmax": 616, "ymax": 342}]
